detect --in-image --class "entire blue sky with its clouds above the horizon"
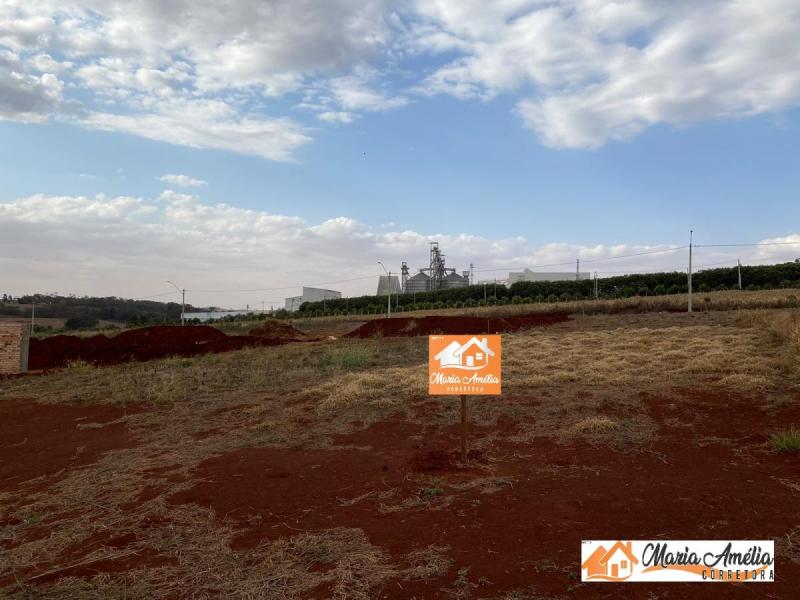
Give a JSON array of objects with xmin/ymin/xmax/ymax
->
[{"xmin": 0, "ymin": 0, "xmax": 800, "ymax": 308}]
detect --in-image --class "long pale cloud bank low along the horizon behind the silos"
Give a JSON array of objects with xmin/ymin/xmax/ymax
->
[{"xmin": 0, "ymin": 190, "xmax": 800, "ymax": 306}]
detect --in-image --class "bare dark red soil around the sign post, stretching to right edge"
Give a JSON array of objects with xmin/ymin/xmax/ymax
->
[{"xmin": 172, "ymin": 391, "xmax": 800, "ymax": 599}]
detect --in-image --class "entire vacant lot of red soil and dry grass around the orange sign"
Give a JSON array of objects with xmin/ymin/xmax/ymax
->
[{"xmin": 0, "ymin": 310, "xmax": 800, "ymax": 600}]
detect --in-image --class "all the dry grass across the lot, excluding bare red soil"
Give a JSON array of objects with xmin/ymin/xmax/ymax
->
[{"xmin": 0, "ymin": 311, "xmax": 797, "ymax": 599}]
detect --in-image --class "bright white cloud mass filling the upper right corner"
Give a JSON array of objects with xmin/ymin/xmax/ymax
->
[{"xmin": 419, "ymin": 0, "xmax": 800, "ymax": 147}]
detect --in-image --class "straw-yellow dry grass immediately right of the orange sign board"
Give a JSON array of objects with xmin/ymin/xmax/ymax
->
[{"xmin": 503, "ymin": 325, "xmax": 782, "ymax": 392}]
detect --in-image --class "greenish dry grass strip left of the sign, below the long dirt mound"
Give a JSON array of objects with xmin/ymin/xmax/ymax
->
[{"xmin": 0, "ymin": 338, "xmax": 424, "ymax": 404}]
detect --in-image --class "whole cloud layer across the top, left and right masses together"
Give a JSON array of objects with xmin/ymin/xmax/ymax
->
[{"xmin": 0, "ymin": 0, "xmax": 800, "ymax": 155}]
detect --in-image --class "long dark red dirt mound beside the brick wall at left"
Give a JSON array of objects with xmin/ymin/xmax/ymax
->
[{"xmin": 28, "ymin": 325, "xmax": 300, "ymax": 369}]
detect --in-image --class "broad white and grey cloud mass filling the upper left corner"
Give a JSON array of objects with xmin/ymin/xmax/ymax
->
[{"xmin": 0, "ymin": 0, "xmax": 398, "ymax": 161}]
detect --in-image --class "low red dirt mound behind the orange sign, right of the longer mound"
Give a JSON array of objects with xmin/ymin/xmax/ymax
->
[{"xmin": 345, "ymin": 313, "xmax": 569, "ymax": 338}]
